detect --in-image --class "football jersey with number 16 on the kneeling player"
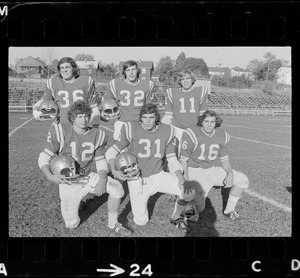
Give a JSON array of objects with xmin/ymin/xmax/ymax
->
[{"xmin": 180, "ymin": 126, "xmax": 230, "ymax": 169}]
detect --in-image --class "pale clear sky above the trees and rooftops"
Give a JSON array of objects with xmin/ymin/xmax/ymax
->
[{"xmin": 8, "ymin": 47, "xmax": 291, "ymax": 69}]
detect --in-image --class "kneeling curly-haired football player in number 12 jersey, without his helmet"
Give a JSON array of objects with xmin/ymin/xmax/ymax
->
[{"xmin": 38, "ymin": 101, "xmax": 131, "ymax": 236}]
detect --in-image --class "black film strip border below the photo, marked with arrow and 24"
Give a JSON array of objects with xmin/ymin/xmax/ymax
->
[{"xmin": 0, "ymin": 238, "xmax": 300, "ymax": 277}]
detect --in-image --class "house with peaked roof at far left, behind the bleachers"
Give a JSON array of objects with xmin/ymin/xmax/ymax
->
[{"xmin": 16, "ymin": 56, "xmax": 47, "ymax": 78}]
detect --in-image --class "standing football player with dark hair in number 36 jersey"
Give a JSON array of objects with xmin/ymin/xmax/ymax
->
[{"xmin": 33, "ymin": 57, "xmax": 100, "ymax": 124}]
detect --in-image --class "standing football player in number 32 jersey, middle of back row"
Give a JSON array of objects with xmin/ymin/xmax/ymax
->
[{"xmin": 107, "ymin": 60, "xmax": 153, "ymax": 139}]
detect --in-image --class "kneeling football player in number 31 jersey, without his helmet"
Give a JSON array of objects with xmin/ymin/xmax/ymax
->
[{"xmin": 105, "ymin": 103, "xmax": 195, "ymax": 229}]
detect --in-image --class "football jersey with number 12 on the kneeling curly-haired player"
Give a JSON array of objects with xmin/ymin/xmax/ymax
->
[{"xmin": 44, "ymin": 122, "xmax": 107, "ymax": 175}]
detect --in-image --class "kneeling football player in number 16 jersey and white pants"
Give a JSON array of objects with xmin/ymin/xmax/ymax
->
[{"xmin": 180, "ymin": 110, "xmax": 249, "ymax": 220}]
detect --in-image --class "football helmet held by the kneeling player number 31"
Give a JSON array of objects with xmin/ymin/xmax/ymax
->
[{"xmin": 115, "ymin": 152, "xmax": 140, "ymax": 179}]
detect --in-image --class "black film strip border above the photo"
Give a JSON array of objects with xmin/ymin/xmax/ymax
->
[{"xmin": 0, "ymin": 1, "xmax": 300, "ymax": 43}]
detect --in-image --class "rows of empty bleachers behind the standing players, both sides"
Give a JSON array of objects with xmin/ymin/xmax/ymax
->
[{"xmin": 8, "ymin": 80, "xmax": 291, "ymax": 115}]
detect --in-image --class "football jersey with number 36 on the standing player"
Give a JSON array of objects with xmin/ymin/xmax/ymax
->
[{"xmin": 42, "ymin": 75, "xmax": 97, "ymax": 123}]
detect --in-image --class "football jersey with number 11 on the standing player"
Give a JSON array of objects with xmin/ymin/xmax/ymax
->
[{"xmin": 165, "ymin": 86, "xmax": 208, "ymax": 129}]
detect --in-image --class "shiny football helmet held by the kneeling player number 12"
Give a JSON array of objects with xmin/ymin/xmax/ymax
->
[{"xmin": 50, "ymin": 154, "xmax": 78, "ymax": 178}]
